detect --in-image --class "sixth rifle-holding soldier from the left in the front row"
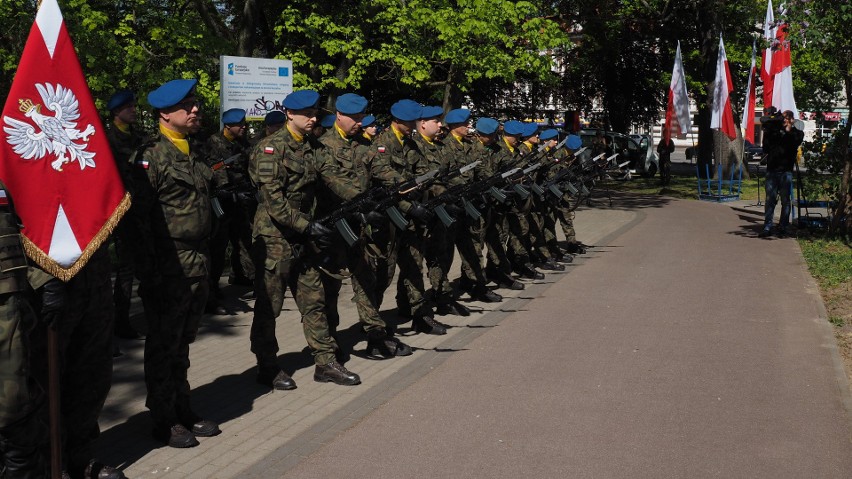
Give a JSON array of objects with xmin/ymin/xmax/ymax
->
[{"xmin": 471, "ymin": 118, "xmax": 524, "ymax": 290}]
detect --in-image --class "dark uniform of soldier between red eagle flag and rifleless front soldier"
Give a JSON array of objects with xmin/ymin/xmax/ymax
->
[{"xmin": 106, "ymin": 123, "xmax": 145, "ymax": 332}]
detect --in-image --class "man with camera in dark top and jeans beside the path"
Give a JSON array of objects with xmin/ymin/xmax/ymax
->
[{"xmin": 758, "ymin": 107, "xmax": 805, "ymax": 238}]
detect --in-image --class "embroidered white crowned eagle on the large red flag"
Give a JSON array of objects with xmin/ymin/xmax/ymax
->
[{"xmin": 3, "ymin": 83, "xmax": 95, "ymax": 171}]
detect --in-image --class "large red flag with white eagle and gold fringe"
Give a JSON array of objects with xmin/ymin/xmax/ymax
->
[{"xmin": 0, "ymin": 0, "xmax": 130, "ymax": 281}]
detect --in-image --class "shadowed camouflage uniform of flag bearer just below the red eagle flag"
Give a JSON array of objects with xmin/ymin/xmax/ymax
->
[{"xmin": 29, "ymin": 245, "xmax": 115, "ymax": 475}]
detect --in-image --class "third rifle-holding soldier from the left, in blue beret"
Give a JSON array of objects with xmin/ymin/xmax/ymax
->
[{"xmin": 365, "ymin": 100, "xmax": 447, "ymax": 334}]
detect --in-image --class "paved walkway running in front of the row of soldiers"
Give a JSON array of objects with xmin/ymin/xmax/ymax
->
[{"xmin": 99, "ymin": 196, "xmax": 852, "ymax": 478}]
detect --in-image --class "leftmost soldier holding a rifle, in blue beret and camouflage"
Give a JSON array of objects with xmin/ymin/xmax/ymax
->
[{"xmin": 249, "ymin": 90, "xmax": 361, "ymax": 389}]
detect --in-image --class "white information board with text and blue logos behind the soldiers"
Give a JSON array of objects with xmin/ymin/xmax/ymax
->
[{"xmin": 219, "ymin": 55, "xmax": 293, "ymax": 121}]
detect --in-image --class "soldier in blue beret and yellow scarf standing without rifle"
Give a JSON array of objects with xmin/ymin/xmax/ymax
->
[{"xmin": 131, "ymin": 80, "xmax": 220, "ymax": 447}]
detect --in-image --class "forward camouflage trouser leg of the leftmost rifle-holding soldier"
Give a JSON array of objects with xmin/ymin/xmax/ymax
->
[{"xmin": 295, "ymin": 263, "xmax": 337, "ymax": 366}]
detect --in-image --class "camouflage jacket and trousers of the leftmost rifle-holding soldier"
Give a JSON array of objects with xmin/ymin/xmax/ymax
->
[{"xmin": 249, "ymin": 127, "xmax": 357, "ymax": 371}]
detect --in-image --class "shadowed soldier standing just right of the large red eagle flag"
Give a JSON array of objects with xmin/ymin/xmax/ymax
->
[{"xmin": 106, "ymin": 90, "xmax": 145, "ymax": 340}]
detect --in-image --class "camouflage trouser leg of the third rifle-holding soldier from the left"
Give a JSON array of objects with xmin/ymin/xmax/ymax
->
[{"xmin": 396, "ymin": 228, "xmax": 426, "ymax": 315}]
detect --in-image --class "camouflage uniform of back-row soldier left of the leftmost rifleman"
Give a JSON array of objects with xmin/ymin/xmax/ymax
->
[{"xmin": 205, "ymin": 132, "xmax": 257, "ymax": 293}]
